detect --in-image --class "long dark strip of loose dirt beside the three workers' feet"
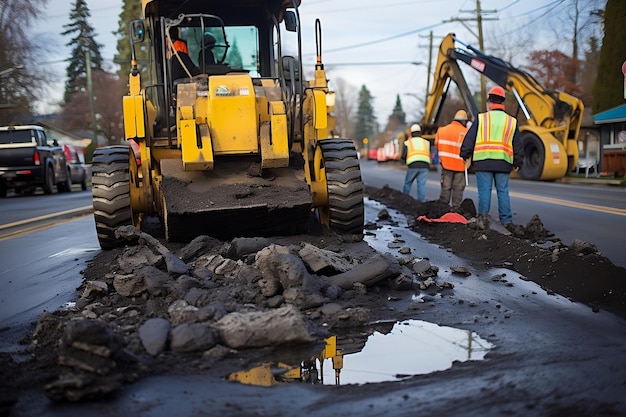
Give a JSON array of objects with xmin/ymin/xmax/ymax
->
[{"xmin": 366, "ymin": 187, "xmax": 626, "ymax": 317}]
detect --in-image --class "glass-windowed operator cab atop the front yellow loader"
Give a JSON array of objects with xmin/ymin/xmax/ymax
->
[{"xmin": 140, "ymin": 0, "xmax": 301, "ymax": 137}]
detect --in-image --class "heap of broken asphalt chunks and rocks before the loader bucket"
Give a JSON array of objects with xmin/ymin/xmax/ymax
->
[{"xmin": 0, "ymin": 226, "xmax": 438, "ymax": 405}]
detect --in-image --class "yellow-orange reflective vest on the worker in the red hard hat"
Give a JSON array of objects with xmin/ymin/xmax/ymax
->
[{"xmin": 473, "ymin": 111, "xmax": 517, "ymax": 164}]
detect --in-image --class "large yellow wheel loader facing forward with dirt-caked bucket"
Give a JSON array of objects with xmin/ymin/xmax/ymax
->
[{"xmin": 92, "ymin": 0, "xmax": 363, "ymax": 249}]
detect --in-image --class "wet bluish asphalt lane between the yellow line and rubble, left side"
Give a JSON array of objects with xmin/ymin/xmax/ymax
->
[{"xmin": 0, "ymin": 216, "xmax": 100, "ymax": 351}]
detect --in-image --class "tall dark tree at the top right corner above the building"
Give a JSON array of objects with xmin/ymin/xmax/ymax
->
[{"xmin": 591, "ymin": 0, "xmax": 626, "ymax": 114}]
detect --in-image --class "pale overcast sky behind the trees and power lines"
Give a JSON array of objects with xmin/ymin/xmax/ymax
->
[{"xmin": 34, "ymin": 0, "xmax": 584, "ymax": 122}]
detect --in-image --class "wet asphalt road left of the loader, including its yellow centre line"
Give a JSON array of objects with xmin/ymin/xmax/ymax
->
[{"xmin": 0, "ymin": 188, "xmax": 100, "ymax": 352}]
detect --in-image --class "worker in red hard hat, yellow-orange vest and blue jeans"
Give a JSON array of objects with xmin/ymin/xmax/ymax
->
[{"xmin": 460, "ymin": 86, "xmax": 524, "ymax": 229}]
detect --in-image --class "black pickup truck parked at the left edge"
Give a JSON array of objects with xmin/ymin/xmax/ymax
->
[{"xmin": 0, "ymin": 126, "xmax": 72, "ymax": 197}]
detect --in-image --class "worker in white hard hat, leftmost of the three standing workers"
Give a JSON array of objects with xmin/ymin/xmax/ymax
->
[{"xmin": 401, "ymin": 124, "xmax": 430, "ymax": 203}]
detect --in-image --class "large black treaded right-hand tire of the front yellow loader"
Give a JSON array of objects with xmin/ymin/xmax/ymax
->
[{"xmin": 318, "ymin": 139, "xmax": 365, "ymax": 234}]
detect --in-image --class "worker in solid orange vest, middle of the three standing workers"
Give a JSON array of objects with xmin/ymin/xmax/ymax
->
[{"xmin": 435, "ymin": 110, "xmax": 467, "ymax": 211}]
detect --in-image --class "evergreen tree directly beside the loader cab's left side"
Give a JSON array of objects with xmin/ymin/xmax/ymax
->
[{"xmin": 113, "ymin": 0, "xmax": 149, "ymax": 87}]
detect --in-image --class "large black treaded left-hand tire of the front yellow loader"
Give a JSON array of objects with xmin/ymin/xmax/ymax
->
[{"xmin": 91, "ymin": 146, "xmax": 133, "ymax": 249}]
